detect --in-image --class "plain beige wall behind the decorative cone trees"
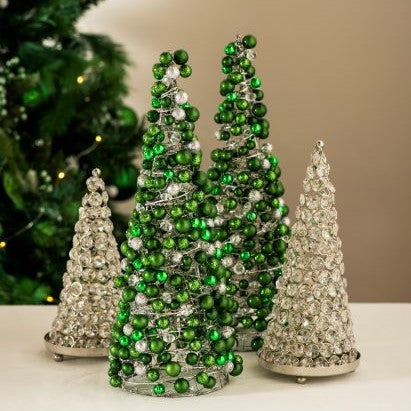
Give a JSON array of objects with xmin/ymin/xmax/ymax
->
[{"xmin": 80, "ymin": 0, "xmax": 411, "ymax": 301}]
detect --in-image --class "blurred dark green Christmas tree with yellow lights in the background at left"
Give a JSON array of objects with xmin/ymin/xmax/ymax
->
[{"xmin": 0, "ymin": 0, "xmax": 141, "ymax": 304}]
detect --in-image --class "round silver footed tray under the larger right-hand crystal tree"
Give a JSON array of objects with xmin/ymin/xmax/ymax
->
[{"xmin": 258, "ymin": 353, "xmax": 360, "ymax": 384}]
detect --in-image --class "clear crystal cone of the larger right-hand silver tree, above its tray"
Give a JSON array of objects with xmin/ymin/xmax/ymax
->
[{"xmin": 259, "ymin": 142, "xmax": 358, "ymax": 367}]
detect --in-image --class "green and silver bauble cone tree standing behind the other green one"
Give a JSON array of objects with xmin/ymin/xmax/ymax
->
[{"xmin": 208, "ymin": 35, "xmax": 290, "ymax": 351}]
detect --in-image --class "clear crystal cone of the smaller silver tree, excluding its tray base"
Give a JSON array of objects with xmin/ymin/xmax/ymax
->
[{"xmin": 49, "ymin": 169, "xmax": 121, "ymax": 348}]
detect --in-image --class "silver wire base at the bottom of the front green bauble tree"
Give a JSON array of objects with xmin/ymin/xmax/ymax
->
[{"xmin": 122, "ymin": 368, "xmax": 232, "ymax": 398}]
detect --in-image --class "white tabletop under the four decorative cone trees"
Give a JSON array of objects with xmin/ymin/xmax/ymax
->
[{"xmin": 0, "ymin": 304, "xmax": 411, "ymax": 411}]
